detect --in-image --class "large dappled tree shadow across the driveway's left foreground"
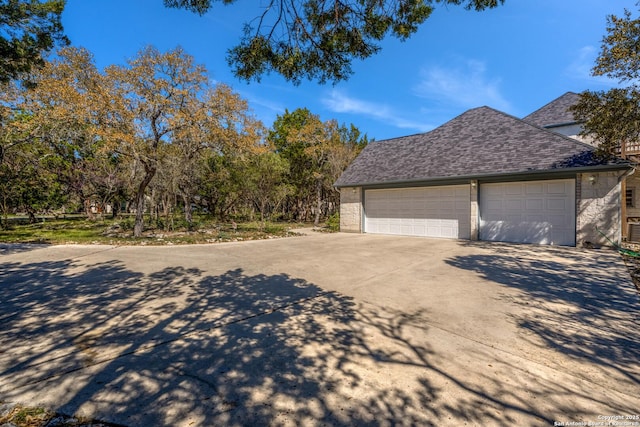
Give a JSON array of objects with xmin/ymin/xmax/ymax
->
[{"xmin": 0, "ymin": 260, "xmax": 433, "ymax": 426}]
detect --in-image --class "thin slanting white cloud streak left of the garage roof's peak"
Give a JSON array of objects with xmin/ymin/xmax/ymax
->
[{"xmin": 322, "ymin": 90, "xmax": 434, "ymax": 132}]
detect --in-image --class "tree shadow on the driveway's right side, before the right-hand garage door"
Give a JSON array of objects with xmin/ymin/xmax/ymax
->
[{"xmin": 446, "ymin": 243, "xmax": 640, "ymax": 395}]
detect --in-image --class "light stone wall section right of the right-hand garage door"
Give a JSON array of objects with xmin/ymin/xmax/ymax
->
[{"xmin": 576, "ymin": 172, "xmax": 623, "ymax": 246}]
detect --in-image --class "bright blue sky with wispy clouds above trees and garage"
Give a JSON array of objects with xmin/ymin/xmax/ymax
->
[{"xmin": 63, "ymin": 0, "xmax": 637, "ymax": 140}]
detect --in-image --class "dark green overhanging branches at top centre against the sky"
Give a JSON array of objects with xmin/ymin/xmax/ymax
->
[{"xmin": 164, "ymin": 0, "xmax": 504, "ymax": 84}]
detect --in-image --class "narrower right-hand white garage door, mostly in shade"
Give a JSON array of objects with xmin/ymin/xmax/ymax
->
[{"xmin": 480, "ymin": 179, "xmax": 576, "ymax": 246}]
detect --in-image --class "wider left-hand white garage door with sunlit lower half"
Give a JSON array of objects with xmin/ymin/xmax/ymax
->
[{"xmin": 364, "ymin": 185, "xmax": 471, "ymax": 239}]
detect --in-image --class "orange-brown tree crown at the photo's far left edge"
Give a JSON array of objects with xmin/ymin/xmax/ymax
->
[{"xmin": 0, "ymin": 48, "xmax": 107, "ymax": 221}]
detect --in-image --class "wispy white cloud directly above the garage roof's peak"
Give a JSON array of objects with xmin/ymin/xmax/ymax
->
[{"xmin": 414, "ymin": 60, "xmax": 511, "ymax": 111}]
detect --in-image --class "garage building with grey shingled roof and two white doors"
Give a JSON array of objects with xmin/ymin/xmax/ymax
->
[{"xmin": 335, "ymin": 107, "xmax": 633, "ymax": 246}]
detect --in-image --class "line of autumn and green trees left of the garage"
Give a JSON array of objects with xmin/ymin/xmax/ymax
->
[{"xmin": 0, "ymin": 47, "xmax": 368, "ymax": 236}]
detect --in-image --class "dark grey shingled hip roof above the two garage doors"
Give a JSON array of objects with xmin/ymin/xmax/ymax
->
[{"xmin": 335, "ymin": 107, "xmax": 629, "ymax": 187}]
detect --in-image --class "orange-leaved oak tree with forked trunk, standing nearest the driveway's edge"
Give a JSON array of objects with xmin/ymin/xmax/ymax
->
[{"xmin": 106, "ymin": 47, "xmax": 208, "ymax": 237}]
